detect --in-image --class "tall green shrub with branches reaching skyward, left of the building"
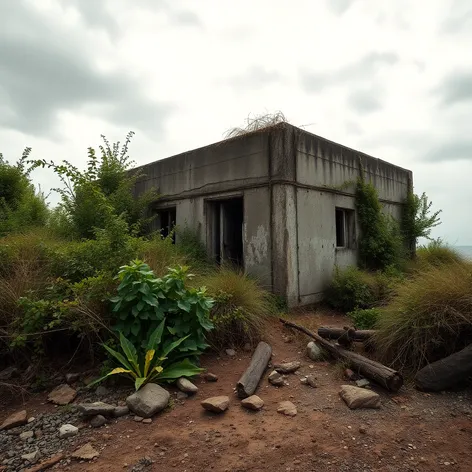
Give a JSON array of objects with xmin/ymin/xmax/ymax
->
[{"xmin": 33, "ymin": 132, "xmax": 157, "ymax": 239}]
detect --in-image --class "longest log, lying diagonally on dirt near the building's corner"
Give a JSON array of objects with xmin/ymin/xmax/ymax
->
[{"xmin": 280, "ymin": 319, "xmax": 403, "ymax": 392}]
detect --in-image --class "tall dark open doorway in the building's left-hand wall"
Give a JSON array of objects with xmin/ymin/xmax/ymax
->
[{"xmin": 208, "ymin": 198, "xmax": 244, "ymax": 267}]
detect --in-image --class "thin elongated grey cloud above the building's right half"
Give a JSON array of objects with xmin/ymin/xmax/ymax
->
[{"xmin": 300, "ymin": 52, "xmax": 399, "ymax": 92}]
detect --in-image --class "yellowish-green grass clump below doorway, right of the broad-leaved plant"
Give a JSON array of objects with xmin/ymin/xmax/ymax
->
[{"xmin": 202, "ymin": 267, "xmax": 276, "ymax": 349}]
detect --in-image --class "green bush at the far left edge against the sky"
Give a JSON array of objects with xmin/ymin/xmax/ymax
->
[{"xmin": 0, "ymin": 148, "xmax": 49, "ymax": 236}]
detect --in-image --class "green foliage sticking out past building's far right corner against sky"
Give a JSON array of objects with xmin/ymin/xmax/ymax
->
[{"xmin": 402, "ymin": 190, "xmax": 441, "ymax": 250}]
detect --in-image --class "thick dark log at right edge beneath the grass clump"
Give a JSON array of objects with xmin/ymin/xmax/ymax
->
[{"xmin": 415, "ymin": 344, "xmax": 472, "ymax": 392}]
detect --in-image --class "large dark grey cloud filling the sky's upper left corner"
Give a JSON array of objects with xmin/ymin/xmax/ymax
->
[{"xmin": 0, "ymin": 1, "xmax": 171, "ymax": 135}]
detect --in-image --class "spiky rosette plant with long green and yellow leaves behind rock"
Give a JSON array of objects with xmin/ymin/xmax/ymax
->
[{"xmin": 89, "ymin": 320, "xmax": 203, "ymax": 390}]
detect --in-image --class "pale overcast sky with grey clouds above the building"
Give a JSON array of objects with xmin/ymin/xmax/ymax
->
[{"xmin": 0, "ymin": 0, "xmax": 472, "ymax": 245}]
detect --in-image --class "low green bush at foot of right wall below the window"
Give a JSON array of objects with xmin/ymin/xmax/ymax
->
[{"xmin": 326, "ymin": 267, "xmax": 403, "ymax": 313}]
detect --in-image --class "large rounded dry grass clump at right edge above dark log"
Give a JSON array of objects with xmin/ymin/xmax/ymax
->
[{"xmin": 375, "ymin": 263, "xmax": 472, "ymax": 372}]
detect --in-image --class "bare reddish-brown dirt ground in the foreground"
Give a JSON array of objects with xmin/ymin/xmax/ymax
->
[{"xmin": 0, "ymin": 313, "xmax": 472, "ymax": 472}]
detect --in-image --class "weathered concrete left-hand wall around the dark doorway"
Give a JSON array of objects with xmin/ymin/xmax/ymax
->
[{"xmin": 135, "ymin": 133, "xmax": 272, "ymax": 289}]
